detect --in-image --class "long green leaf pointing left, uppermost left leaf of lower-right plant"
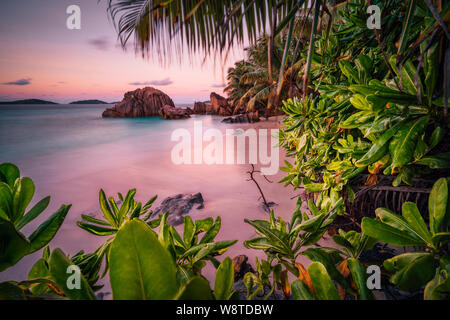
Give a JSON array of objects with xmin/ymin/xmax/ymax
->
[{"xmin": 361, "ymin": 217, "xmax": 424, "ymax": 246}]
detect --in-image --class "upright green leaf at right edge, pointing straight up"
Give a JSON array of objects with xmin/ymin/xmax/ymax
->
[{"xmin": 428, "ymin": 178, "xmax": 448, "ymax": 234}]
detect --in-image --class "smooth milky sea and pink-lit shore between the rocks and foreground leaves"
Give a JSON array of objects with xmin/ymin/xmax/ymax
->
[{"xmin": 0, "ymin": 105, "xmax": 296, "ymax": 292}]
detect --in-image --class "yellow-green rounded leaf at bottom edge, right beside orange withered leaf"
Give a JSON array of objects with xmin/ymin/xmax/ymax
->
[{"xmin": 308, "ymin": 262, "xmax": 339, "ymax": 300}]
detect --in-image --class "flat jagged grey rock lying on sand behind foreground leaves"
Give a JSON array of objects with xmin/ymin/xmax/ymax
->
[{"xmin": 153, "ymin": 192, "xmax": 204, "ymax": 226}]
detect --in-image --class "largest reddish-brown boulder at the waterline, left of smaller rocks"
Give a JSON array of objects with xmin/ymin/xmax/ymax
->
[{"xmin": 103, "ymin": 87, "xmax": 175, "ymax": 118}]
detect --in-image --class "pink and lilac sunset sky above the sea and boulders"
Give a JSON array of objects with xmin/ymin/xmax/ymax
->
[{"xmin": 0, "ymin": 0, "xmax": 243, "ymax": 103}]
